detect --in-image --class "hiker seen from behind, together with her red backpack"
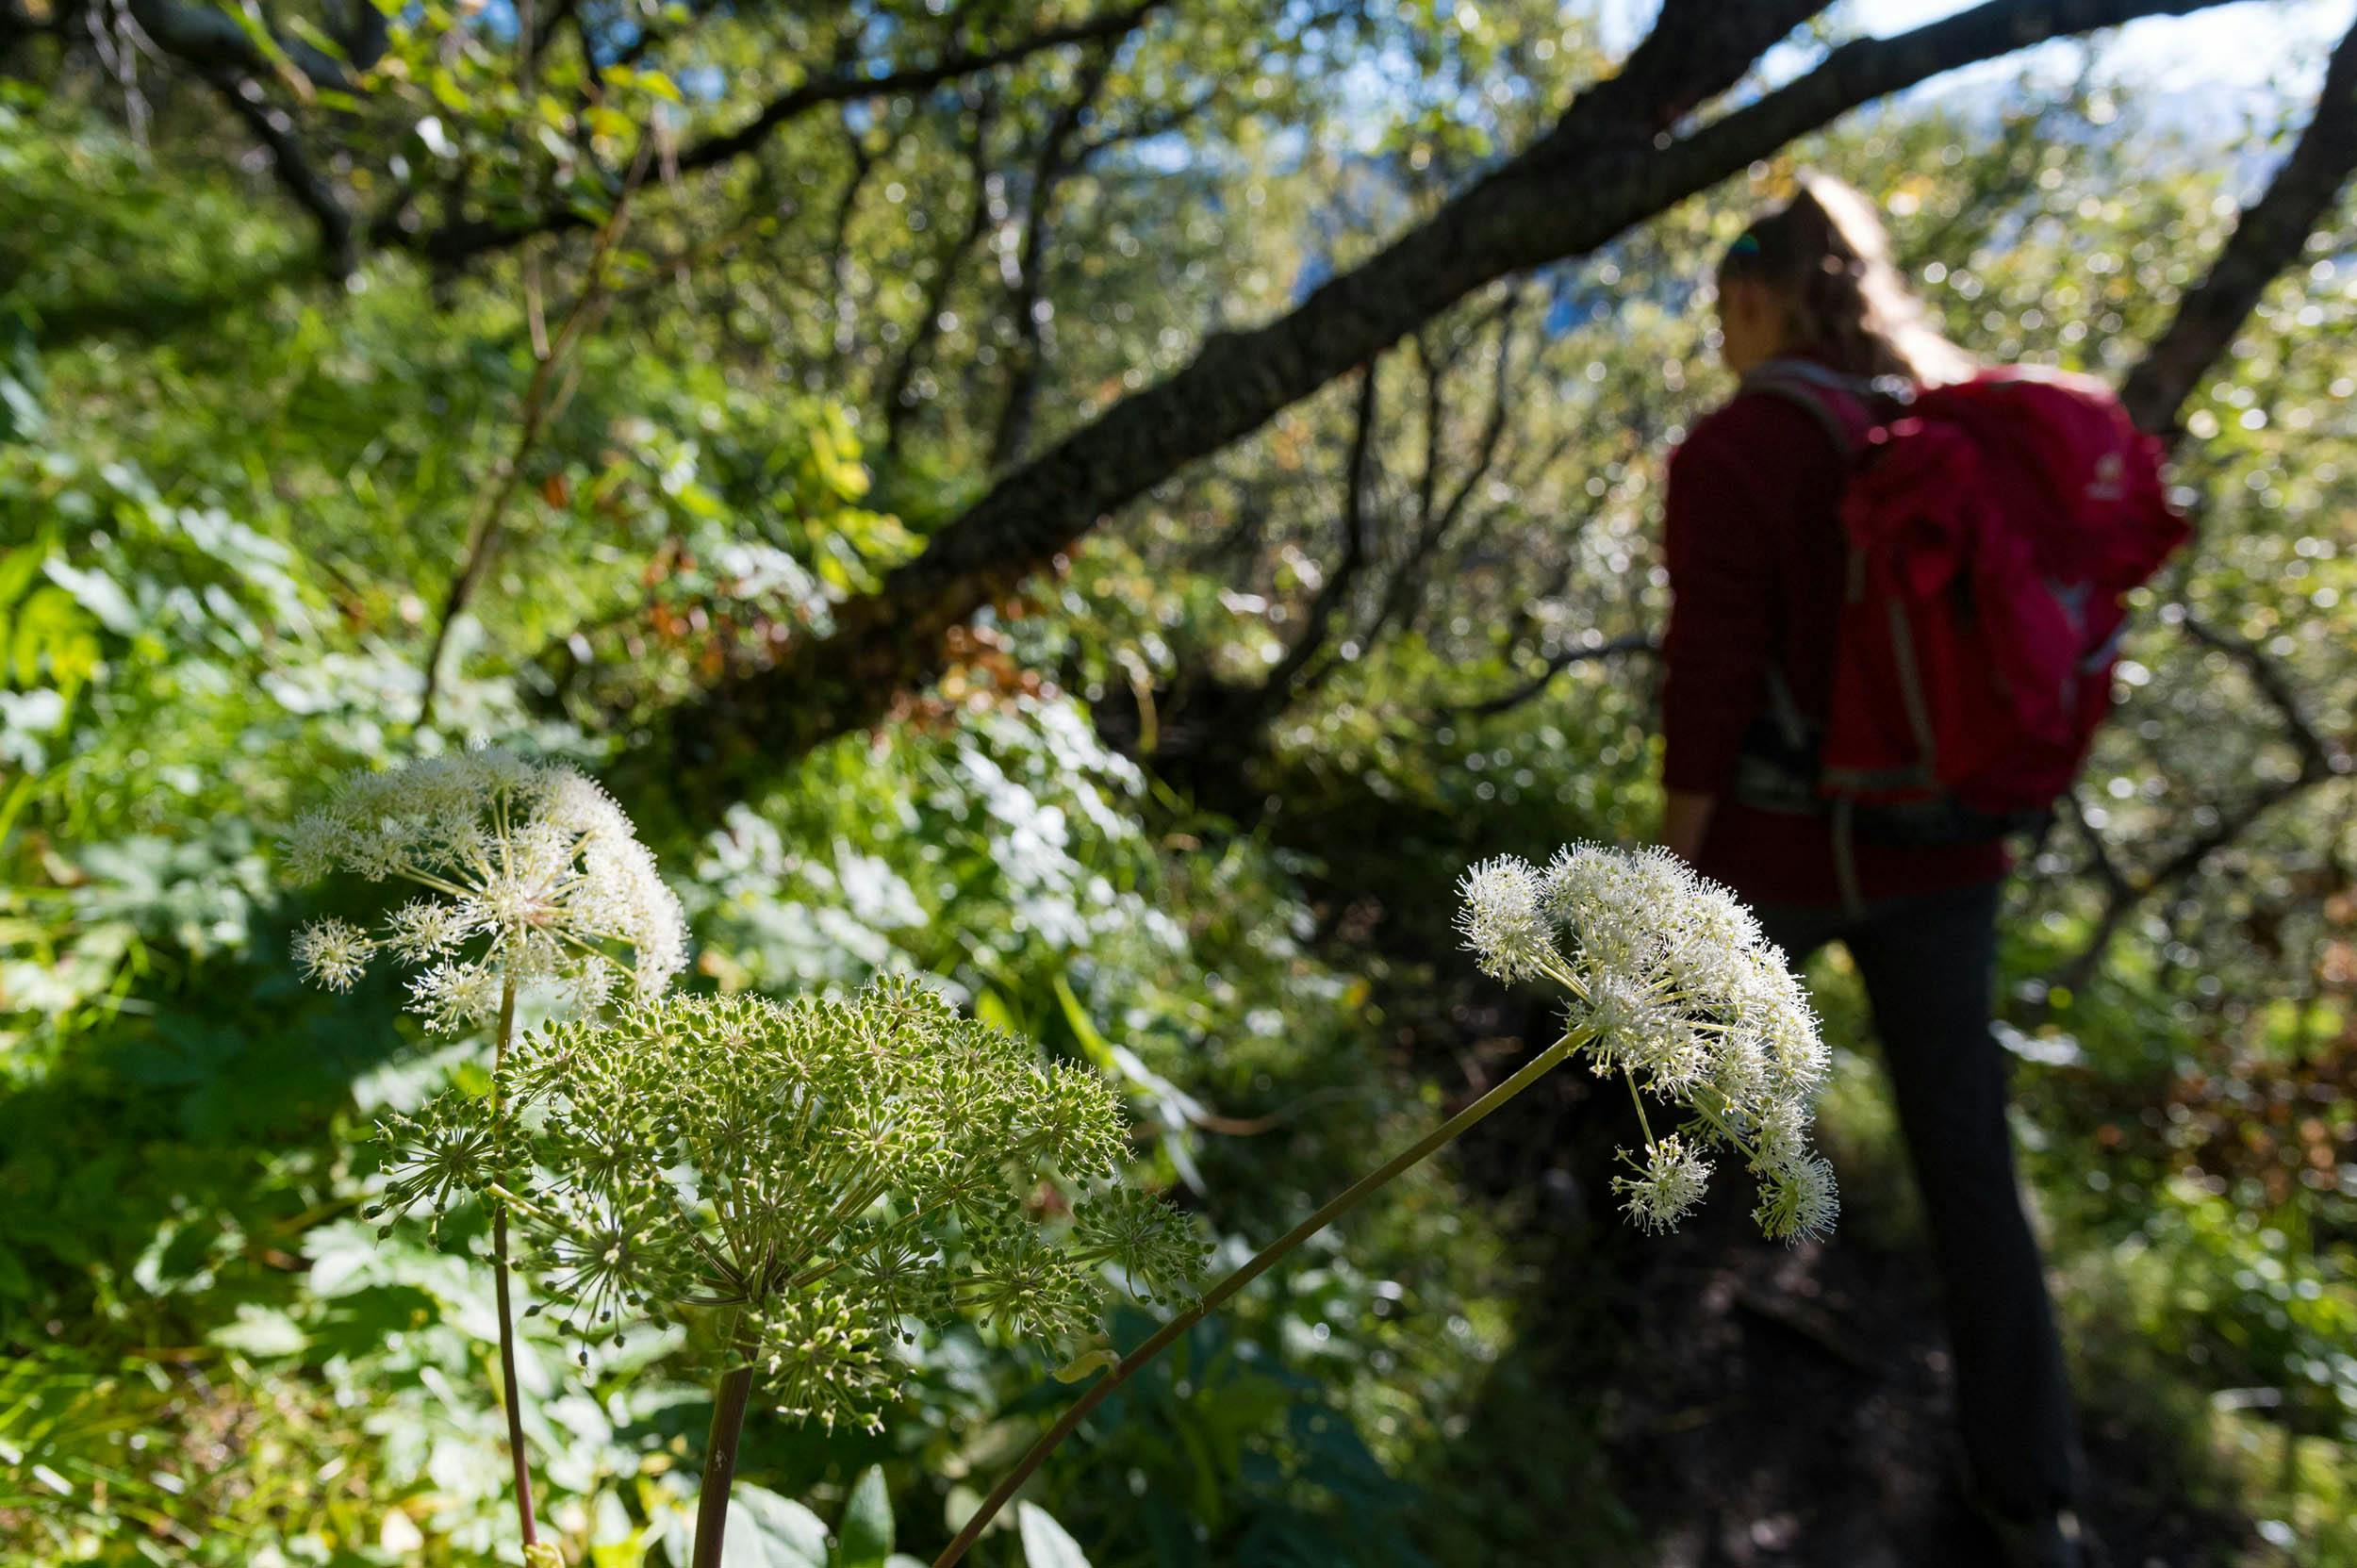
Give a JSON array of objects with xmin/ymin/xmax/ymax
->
[{"xmin": 1662, "ymin": 177, "xmax": 2183, "ymax": 1568}]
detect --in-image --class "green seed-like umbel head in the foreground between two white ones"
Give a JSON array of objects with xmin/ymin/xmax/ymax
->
[{"xmin": 380, "ymin": 981, "xmax": 1197, "ymax": 1431}]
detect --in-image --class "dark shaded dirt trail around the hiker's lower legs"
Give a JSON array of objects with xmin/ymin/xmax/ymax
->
[{"xmin": 1607, "ymin": 1183, "xmax": 2251, "ymax": 1568}]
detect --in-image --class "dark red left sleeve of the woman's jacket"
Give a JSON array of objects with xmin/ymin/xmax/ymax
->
[{"xmin": 1662, "ymin": 399, "xmax": 1789, "ymax": 797}]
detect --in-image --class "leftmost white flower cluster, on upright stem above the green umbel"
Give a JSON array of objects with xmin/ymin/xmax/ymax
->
[{"xmin": 286, "ymin": 748, "xmax": 688, "ymax": 1032}]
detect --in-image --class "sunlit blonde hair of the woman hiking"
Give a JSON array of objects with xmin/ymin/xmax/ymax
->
[{"xmin": 1719, "ymin": 173, "xmax": 1975, "ymax": 387}]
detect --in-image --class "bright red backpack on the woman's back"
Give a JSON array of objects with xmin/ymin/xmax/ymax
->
[{"xmin": 1744, "ymin": 361, "xmax": 2190, "ymax": 842}]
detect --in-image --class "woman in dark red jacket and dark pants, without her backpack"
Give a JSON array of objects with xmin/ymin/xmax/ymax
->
[{"xmin": 1662, "ymin": 177, "xmax": 2084, "ymax": 1568}]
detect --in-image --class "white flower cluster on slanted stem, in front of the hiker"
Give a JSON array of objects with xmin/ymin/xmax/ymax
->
[{"xmin": 1457, "ymin": 844, "xmax": 1841, "ymax": 1240}]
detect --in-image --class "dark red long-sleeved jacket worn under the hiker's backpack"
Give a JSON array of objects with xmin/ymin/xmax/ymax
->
[{"xmin": 1662, "ymin": 374, "xmax": 2006, "ymax": 905}]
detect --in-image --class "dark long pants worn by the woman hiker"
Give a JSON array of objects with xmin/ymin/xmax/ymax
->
[{"xmin": 1758, "ymin": 882, "xmax": 2079, "ymax": 1518}]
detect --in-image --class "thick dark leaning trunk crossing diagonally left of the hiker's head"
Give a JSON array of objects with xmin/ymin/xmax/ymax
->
[{"xmin": 649, "ymin": 0, "xmax": 2244, "ymax": 816}]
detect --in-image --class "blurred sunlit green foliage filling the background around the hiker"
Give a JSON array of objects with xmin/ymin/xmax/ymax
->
[{"xmin": 0, "ymin": 0, "xmax": 2357, "ymax": 1568}]
